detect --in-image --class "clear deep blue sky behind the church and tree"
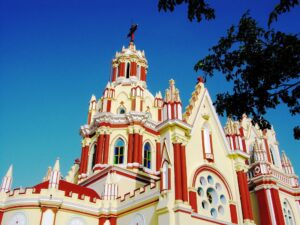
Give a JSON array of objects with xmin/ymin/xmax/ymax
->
[{"xmin": 0, "ymin": 0, "xmax": 300, "ymax": 187}]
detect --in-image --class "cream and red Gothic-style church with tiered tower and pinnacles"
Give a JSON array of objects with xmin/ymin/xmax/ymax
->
[{"xmin": 0, "ymin": 33, "xmax": 300, "ymax": 225}]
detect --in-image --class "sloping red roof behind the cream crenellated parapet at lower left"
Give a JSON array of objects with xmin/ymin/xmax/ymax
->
[{"xmin": 33, "ymin": 180, "xmax": 101, "ymax": 201}]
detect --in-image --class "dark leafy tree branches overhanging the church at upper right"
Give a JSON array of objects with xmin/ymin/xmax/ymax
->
[{"xmin": 158, "ymin": 0, "xmax": 300, "ymax": 139}]
